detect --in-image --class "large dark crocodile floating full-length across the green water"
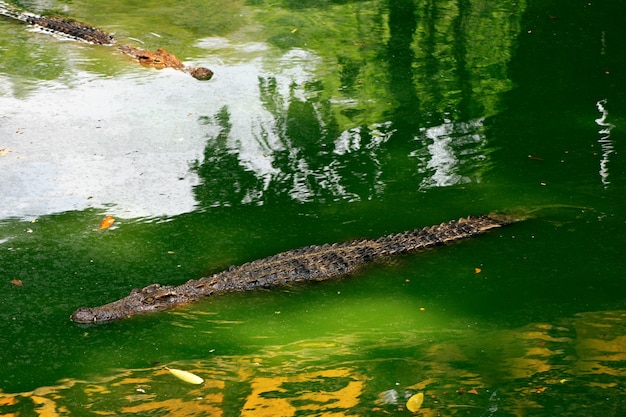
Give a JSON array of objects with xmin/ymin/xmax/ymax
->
[{"xmin": 71, "ymin": 214, "xmax": 522, "ymax": 324}]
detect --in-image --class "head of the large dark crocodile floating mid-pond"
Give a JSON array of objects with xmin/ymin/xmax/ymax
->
[{"xmin": 70, "ymin": 284, "xmax": 187, "ymax": 324}]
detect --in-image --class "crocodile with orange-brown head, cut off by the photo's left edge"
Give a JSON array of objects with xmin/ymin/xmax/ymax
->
[{"xmin": 0, "ymin": 1, "xmax": 213, "ymax": 81}]
